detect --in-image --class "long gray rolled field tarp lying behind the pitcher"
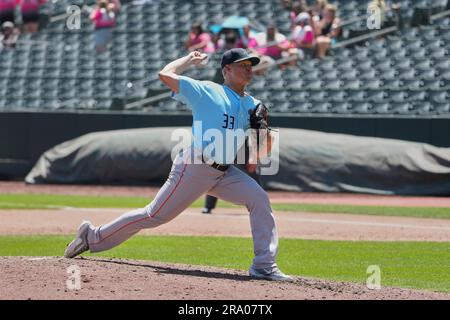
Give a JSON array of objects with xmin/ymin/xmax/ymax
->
[{"xmin": 25, "ymin": 127, "xmax": 450, "ymax": 196}]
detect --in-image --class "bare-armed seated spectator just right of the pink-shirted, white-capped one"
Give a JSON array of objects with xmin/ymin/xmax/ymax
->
[{"xmin": 316, "ymin": 4, "xmax": 342, "ymax": 59}]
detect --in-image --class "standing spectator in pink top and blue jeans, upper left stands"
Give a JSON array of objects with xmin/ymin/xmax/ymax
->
[{"xmin": 90, "ymin": 0, "xmax": 120, "ymax": 53}]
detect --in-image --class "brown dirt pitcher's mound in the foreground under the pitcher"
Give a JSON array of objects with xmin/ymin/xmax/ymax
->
[{"xmin": 0, "ymin": 257, "xmax": 450, "ymax": 300}]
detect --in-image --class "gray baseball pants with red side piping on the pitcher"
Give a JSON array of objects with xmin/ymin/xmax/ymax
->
[{"xmin": 88, "ymin": 151, "xmax": 278, "ymax": 269}]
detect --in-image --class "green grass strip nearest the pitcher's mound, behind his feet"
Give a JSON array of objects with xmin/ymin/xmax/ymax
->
[{"xmin": 0, "ymin": 236, "xmax": 450, "ymax": 292}]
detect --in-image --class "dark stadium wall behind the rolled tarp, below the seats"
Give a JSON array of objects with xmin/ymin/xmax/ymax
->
[{"xmin": 0, "ymin": 112, "xmax": 450, "ymax": 179}]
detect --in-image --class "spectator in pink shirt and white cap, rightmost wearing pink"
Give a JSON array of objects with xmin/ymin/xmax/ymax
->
[{"xmin": 292, "ymin": 12, "xmax": 315, "ymax": 57}]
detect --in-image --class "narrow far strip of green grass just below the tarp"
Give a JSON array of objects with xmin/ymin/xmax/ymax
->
[{"xmin": 0, "ymin": 194, "xmax": 450, "ymax": 219}]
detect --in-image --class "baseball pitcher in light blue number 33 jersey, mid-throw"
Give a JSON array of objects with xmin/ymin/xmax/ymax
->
[{"xmin": 64, "ymin": 49, "xmax": 292, "ymax": 281}]
